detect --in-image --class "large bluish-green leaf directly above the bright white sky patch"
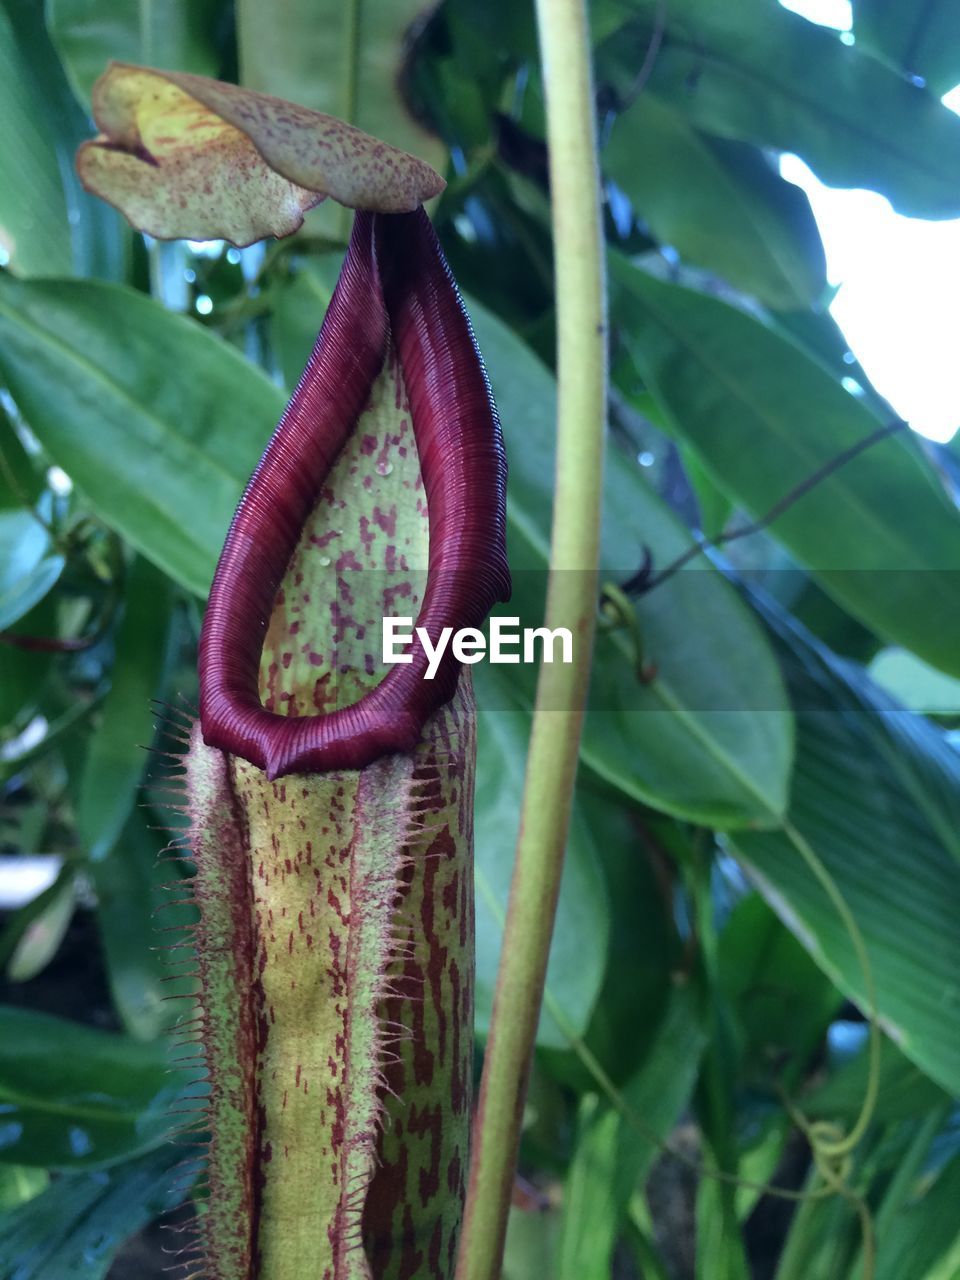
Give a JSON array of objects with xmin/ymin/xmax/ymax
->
[{"xmin": 598, "ymin": 0, "xmax": 960, "ymax": 218}]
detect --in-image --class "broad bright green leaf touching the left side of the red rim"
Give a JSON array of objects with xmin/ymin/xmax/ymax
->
[{"xmin": 0, "ymin": 276, "xmax": 284, "ymax": 595}]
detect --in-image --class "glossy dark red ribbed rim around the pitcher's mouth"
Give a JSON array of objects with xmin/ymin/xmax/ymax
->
[{"xmin": 200, "ymin": 209, "xmax": 509, "ymax": 778}]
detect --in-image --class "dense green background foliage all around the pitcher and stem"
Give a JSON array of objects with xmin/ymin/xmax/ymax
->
[{"xmin": 0, "ymin": 0, "xmax": 960, "ymax": 1280}]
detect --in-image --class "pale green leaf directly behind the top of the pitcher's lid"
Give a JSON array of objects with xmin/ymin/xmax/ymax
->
[{"xmin": 237, "ymin": 0, "xmax": 445, "ymax": 192}]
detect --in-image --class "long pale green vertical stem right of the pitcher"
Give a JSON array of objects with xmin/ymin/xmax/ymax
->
[{"xmin": 457, "ymin": 0, "xmax": 607, "ymax": 1280}]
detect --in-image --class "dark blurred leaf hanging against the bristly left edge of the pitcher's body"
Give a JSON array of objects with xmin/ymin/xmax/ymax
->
[{"xmin": 90, "ymin": 808, "xmax": 196, "ymax": 1041}]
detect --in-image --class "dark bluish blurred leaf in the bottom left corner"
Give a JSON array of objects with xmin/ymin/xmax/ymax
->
[{"xmin": 0, "ymin": 1144, "xmax": 191, "ymax": 1280}]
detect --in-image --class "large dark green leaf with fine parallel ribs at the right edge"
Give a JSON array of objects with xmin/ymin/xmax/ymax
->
[{"xmin": 731, "ymin": 599, "xmax": 960, "ymax": 1092}]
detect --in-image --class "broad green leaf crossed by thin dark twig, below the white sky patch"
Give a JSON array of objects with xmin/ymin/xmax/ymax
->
[{"xmin": 611, "ymin": 256, "xmax": 960, "ymax": 675}]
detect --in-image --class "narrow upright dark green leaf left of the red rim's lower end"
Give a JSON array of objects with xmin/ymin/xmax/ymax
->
[{"xmin": 77, "ymin": 558, "xmax": 173, "ymax": 861}]
